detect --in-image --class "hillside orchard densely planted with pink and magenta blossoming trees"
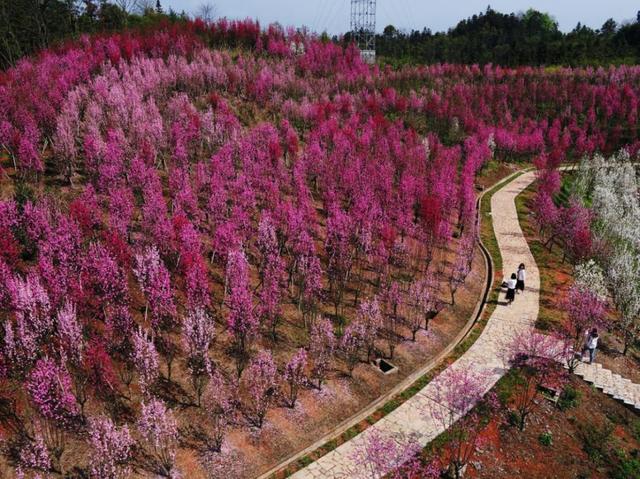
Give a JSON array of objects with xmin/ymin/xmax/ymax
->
[{"xmin": 0, "ymin": 20, "xmax": 640, "ymax": 478}]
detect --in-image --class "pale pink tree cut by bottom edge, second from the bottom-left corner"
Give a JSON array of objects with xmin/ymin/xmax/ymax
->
[{"xmin": 88, "ymin": 417, "xmax": 135, "ymax": 479}]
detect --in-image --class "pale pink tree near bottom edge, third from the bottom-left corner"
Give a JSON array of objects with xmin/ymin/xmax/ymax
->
[{"xmin": 137, "ymin": 399, "xmax": 180, "ymax": 479}]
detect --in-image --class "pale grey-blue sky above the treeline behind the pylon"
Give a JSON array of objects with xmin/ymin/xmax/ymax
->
[{"xmin": 161, "ymin": 0, "xmax": 640, "ymax": 33}]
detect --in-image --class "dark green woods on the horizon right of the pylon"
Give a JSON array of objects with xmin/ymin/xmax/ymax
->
[{"xmin": 377, "ymin": 8, "xmax": 640, "ymax": 66}]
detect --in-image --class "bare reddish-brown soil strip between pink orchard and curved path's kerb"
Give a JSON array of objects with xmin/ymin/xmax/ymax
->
[{"xmin": 224, "ymin": 250, "xmax": 486, "ymax": 478}]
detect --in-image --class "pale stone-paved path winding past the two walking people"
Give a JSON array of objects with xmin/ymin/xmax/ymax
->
[{"xmin": 291, "ymin": 172, "xmax": 540, "ymax": 479}]
